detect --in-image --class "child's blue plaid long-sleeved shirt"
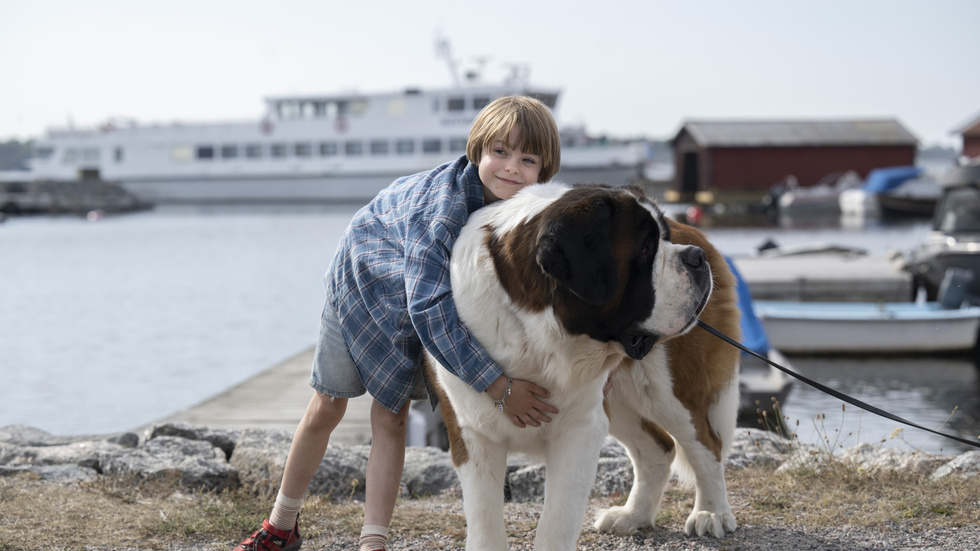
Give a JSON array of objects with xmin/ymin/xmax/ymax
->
[{"xmin": 327, "ymin": 156, "xmax": 503, "ymax": 411}]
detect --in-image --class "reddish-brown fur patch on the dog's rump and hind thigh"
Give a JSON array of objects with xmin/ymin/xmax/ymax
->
[{"xmin": 665, "ymin": 220, "xmax": 741, "ymax": 461}]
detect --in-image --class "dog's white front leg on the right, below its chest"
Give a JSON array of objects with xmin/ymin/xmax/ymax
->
[{"xmin": 534, "ymin": 422, "xmax": 608, "ymax": 551}]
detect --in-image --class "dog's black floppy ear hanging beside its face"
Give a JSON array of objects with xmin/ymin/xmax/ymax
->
[{"xmin": 537, "ymin": 198, "xmax": 616, "ymax": 304}]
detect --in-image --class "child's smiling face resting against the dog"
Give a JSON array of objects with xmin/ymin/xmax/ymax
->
[{"xmin": 479, "ymin": 128, "xmax": 541, "ymax": 204}]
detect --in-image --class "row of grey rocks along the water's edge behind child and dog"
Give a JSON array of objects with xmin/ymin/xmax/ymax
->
[{"xmin": 0, "ymin": 423, "xmax": 980, "ymax": 502}]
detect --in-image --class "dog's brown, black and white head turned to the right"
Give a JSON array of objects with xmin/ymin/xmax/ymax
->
[{"xmin": 489, "ymin": 184, "xmax": 712, "ymax": 359}]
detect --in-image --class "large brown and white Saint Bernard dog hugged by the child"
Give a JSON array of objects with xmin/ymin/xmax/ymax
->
[{"xmin": 425, "ymin": 183, "xmax": 739, "ymax": 551}]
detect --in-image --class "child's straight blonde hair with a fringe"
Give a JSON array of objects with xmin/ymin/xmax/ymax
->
[{"xmin": 466, "ymin": 96, "xmax": 561, "ymax": 182}]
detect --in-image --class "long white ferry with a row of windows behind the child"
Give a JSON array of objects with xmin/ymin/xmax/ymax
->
[{"xmin": 21, "ymin": 78, "xmax": 647, "ymax": 203}]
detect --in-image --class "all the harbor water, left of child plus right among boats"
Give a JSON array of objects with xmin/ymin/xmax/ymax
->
[{"xmin": 0, "ymin": 205, "xmax": 980, "ymax": 453}]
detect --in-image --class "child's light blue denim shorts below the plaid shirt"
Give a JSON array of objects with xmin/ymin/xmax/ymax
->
[{"xmin": 310, "ymin": 298, "xmax": 427, "ymax": 406}]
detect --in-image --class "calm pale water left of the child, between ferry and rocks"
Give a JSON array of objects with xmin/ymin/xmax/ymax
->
[{"xmin": 0, "ymin": 207, "xmax": 356, "ymax": 434}]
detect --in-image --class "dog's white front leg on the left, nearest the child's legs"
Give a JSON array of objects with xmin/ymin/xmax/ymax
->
[{"xmin": 456, "ymin": 433, "xmax": 507, "ymax": 551}]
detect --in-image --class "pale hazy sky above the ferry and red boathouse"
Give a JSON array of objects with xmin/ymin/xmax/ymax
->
[{"xmin": 0, "ymin": 0, "xmax": 980, "ymax": 147}]
